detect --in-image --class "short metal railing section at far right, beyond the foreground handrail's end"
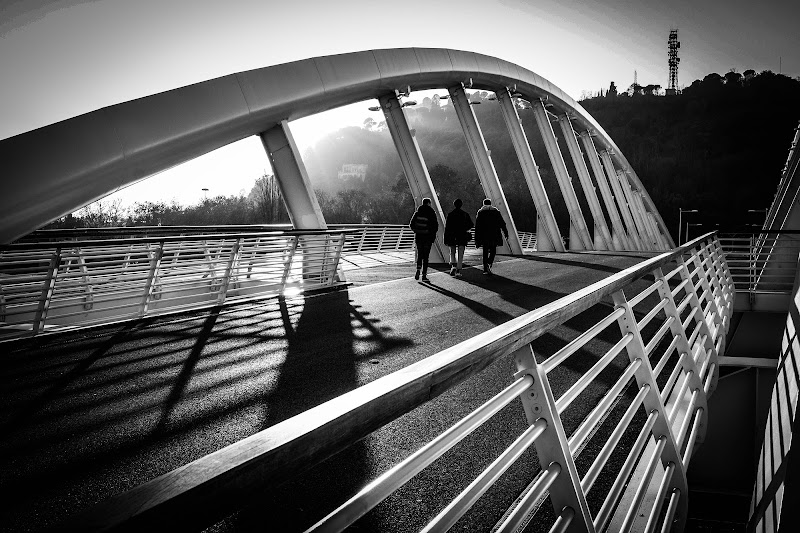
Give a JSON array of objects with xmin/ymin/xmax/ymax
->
[{"xmin": 719, "ymin": 231, "xmax": 800, "ymax": 294}]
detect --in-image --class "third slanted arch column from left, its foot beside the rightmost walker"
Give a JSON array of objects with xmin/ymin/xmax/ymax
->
[{"xmin": 447, "ymin": 84, "xmax": 523, "ymax": 255}]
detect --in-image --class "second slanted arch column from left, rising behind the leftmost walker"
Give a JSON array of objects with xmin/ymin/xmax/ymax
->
[{"xmin": 379, "ymin": 94, "xmax": 449, "ymax": 263}]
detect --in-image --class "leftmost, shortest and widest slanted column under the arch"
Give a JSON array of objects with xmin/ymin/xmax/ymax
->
[{"xmin": 259, "ymin": 120, "xmax": 327, "ymax": 229}]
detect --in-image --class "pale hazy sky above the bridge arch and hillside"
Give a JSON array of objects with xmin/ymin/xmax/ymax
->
[{"xmin": 0, "ymin": 0, "xmax": 800, "ymax": 207}]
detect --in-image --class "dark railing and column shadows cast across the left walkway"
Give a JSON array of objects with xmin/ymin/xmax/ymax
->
[{"xmin": 0, "ymin": 292, "xmax": 411, "ymax": 529}]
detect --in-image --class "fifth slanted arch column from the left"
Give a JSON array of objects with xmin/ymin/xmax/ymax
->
[{"xmin": 531, "ymin": 100, "xmax": 594, "ymax": 250}]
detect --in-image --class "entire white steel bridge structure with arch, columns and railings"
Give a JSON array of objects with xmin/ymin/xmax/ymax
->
[{"xmin": 0, "ymin": 48, "xmax": 797, "ymax": 532}]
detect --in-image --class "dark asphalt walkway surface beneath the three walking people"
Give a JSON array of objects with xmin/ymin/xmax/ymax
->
[{"xmin": 0, "ymin": 253, "xmax": 656, "ymax": 531}]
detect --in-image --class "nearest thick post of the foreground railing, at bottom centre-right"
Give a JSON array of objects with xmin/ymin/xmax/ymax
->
[{"xmin": 514, "ymin": 344, "xmax": 595, "ymax": 533}]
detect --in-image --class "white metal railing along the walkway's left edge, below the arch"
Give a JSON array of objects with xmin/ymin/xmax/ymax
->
[{"xmin": 0, "ymin": 230, "xmax": 352, "ymax": 337}]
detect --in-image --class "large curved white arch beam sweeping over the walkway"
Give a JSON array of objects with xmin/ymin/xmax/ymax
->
[{"xmin": 0, "ymin": 48, "xmax": 674, "ymax": 246}]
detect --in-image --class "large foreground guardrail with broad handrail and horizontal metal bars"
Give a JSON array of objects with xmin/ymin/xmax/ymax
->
[{"xmin": 66, "ymin": 234, "xmax": 735, "ymax": 532}]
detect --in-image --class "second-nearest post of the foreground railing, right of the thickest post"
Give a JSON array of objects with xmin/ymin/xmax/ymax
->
[{"xmin": 612, "ymin": 290, "xmax": 689, "ymax": 533}]
